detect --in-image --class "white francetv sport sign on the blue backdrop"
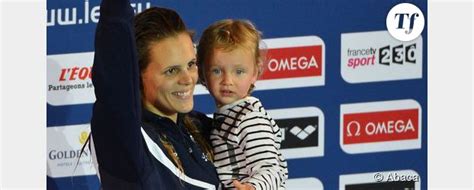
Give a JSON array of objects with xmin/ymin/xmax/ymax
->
[{"xmin": 341, "ymin": 31, "xmax": 423, "ymax": 83}]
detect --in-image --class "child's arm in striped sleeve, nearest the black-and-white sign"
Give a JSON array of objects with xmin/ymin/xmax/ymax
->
[{"xmin": 238, "ymin": 112, "xmax": 286, "ymax": 189}]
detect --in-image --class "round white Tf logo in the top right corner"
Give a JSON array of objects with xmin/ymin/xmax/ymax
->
[{"xmin": 386, "ymin": 3, "xmax": 425, "ymax": 42}]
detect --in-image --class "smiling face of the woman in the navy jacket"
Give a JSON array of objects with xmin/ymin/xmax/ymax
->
[{"xmin": 142, "ymin": 32, "xmax": 198, "ymax": 121}]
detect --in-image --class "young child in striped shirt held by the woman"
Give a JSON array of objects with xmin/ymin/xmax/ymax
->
[{"xmin": 197, "ymin": 19, "xmax": 288, "ymax": 189}]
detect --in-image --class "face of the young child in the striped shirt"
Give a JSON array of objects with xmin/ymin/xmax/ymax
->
[{"xmin": 205, "ymin": 48, "xmax": 258, "ymax": 107}]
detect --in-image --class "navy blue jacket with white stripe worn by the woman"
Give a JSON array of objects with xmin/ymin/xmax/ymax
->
[{"xmin": 91, "ymin": 0, "xmax": 219, "ymax": 190}]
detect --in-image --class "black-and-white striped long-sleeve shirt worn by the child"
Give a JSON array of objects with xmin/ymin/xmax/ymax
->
[{"xmin": 211, "ymin": 97, "xmax": 288, "ymax": 189}]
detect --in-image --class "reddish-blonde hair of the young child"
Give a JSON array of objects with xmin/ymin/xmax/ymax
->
[{"xmin": 197, "ymin": 19, "xmax": 263, "ymax": 93}]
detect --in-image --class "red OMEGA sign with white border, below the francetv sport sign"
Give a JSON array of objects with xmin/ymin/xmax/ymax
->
[{"xmin": 340, "ymin": 99, "xmax": 422, "ymax": 154}]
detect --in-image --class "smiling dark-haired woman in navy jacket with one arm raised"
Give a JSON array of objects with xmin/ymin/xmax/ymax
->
[{"xmin": 91, "ymin": 0, "xmax": 219, "ymax": 190}]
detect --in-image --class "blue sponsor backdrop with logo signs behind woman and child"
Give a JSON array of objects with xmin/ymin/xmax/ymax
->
[{"xmin": 46, "ymin": 0, "xmax": 428, "ymax": 190}]
